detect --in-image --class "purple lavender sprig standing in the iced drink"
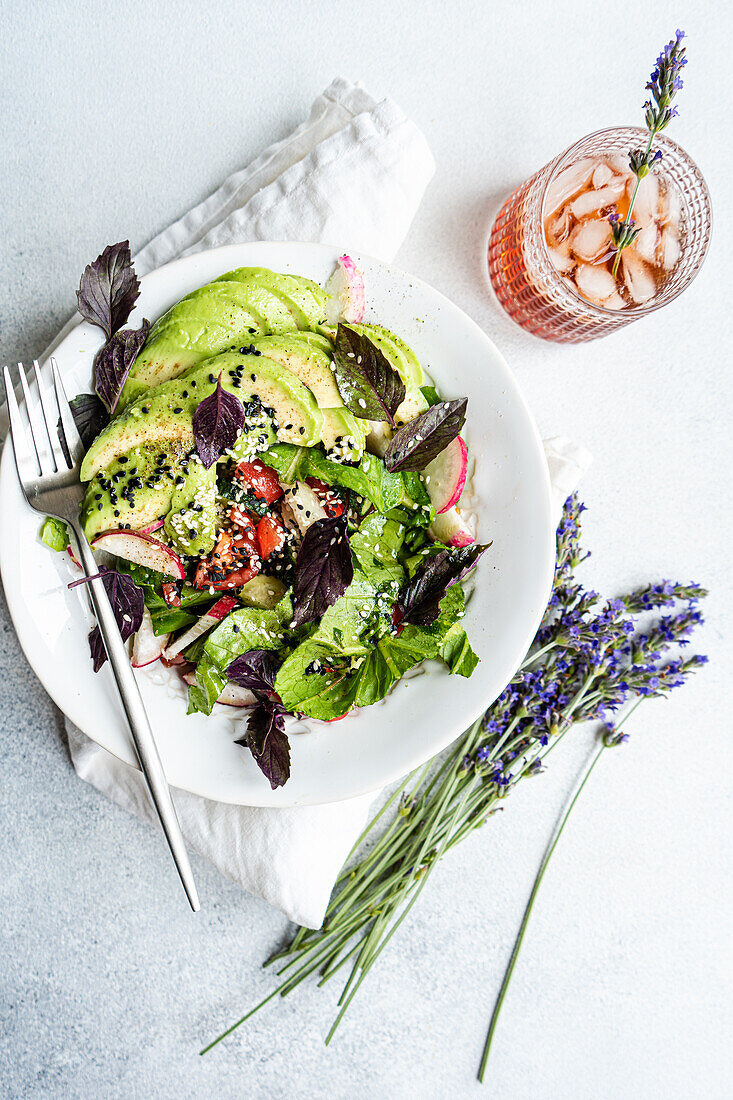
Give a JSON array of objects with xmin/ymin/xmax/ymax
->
[{"xmin": 609, "ymin": 30, "xmax": 687, "ymax": 278}]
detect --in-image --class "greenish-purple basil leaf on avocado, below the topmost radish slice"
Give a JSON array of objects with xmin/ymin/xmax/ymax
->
[{"xmin": 333, "ymin": 325, "xmax": 405, "ymax": 428}]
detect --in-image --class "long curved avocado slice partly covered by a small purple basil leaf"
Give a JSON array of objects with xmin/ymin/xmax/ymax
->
[{"xmin": 80, "ymin": 352, "xmax": 324, "ymax": 481}]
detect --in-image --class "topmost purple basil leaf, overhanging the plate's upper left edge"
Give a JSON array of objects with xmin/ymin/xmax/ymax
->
[{"xmin": 76, "ymin": 241, "xmax": 140, "ymax": 340}]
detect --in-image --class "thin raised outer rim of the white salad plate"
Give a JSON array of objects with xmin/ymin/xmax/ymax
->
[{"xmin": 0, "ymin": 241, "xmax": 555, "ymax": 809}]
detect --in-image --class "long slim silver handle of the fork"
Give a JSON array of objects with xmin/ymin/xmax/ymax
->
[{"xmin": 73, "ymin": 524, "xmax": 200, "ymax": 913}]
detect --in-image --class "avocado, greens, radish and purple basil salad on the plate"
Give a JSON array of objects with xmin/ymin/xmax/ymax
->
[{"xmin": 42, "ymin": 242, "xmax": 485, "ymax": 788}]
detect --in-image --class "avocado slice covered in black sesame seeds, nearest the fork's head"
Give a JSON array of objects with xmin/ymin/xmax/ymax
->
[{"xmin": 81, "ymin": 442, "xmax": 186, "ymax": 540}]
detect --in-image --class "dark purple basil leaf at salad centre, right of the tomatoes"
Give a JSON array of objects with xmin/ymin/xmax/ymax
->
[{"xmin": 291, "ymin": 513, "xmax": 353, "ymax": 627}]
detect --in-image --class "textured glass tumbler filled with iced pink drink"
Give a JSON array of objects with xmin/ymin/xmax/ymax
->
[{"xmin": 489, "ymin": 127, "xmax": 712, "ymax": 343}]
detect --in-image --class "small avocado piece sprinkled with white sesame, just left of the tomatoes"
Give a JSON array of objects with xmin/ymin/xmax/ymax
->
[{"xmin": 164, "ymin": 454, "xmax": 217, "ymax": 558}]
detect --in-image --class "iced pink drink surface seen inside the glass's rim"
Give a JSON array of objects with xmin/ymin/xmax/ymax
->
[{"xmin": 544, "ymin": 154, "xmax": 682, "ymax": 310}]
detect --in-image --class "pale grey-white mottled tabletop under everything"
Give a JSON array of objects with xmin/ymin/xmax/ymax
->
[{"xmin": 0, "ymin": 0, "xmax": 733, "ymax": 1100}]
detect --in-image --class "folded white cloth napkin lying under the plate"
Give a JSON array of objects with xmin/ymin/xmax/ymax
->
[{"xmin": 4, "ymin": 79, "xmax": 590, "ymax": 927}]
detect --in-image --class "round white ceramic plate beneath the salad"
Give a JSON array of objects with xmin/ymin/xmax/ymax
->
[{"xmin": 0, "ymin": 243, "xmax": 555, "ymax": 806}]
